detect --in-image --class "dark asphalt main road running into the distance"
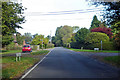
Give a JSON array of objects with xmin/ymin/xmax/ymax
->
[{"xmin": 25, "ymin": 47, "xmax": 118, "ymax": 78}]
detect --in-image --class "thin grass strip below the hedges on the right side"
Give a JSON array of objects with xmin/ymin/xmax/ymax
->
[{"xmin": 68, "ymin": 48, "xmax": 120, "ymax": 53}]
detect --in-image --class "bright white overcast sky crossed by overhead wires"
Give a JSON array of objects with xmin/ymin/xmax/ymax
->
[{"xmin": 15, "ymin": 0, "xmax": 103, "ymax": 36}]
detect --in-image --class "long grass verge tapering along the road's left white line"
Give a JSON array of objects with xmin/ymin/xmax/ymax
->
[{"xmin": 1, "ymin": 50, "xmax": 49, "ymax": 79}]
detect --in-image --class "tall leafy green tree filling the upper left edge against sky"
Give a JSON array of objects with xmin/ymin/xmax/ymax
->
[{"xmin": 0, "ymin": 2, "xmax": 25, "ymax": 47}]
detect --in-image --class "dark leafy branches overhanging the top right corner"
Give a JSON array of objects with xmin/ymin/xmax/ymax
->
[{"xmin": 92, "ymin": 1, "xmax": 120, "ymax": 26}]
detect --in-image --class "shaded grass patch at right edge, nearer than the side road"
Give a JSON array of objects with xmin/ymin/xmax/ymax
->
[{"xmin": 104, "ymin": 56, "xmax": 120, "ymax": 67}]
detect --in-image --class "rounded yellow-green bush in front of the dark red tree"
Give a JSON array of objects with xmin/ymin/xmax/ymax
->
[{"xmin": 85, "ymin": 32, "xmax": 109, "ymax": 44}]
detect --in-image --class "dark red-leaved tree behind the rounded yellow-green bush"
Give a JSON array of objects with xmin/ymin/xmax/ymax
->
[{"xmin": 91, "ymin": 27, "xmax": 112, "ymax": 39}]
